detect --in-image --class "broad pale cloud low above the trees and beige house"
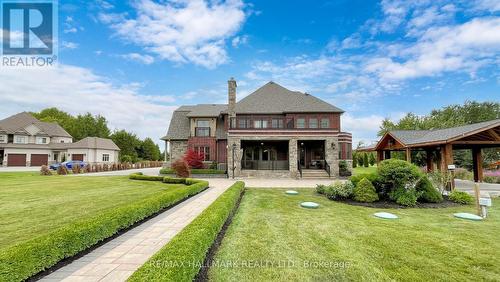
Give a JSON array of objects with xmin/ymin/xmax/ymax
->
[{"xmin": 0, "ymin": 64, "xmax": 176, "ymax": 142}]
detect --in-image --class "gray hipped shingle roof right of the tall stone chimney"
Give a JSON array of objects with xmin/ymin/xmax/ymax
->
[{"xmin": 231, "ymin": 81, "xmax": 344, "ymax": 114}]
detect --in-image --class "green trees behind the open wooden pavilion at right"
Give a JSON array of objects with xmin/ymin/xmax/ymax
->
[{"xmin": 370, "ymin": 101, "xmax": 500, "ymax": 170}]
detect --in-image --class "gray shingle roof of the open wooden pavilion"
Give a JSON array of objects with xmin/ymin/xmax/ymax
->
[{"xmin": 389, "ymin": 119, "xmax": 500, "ymax": 145}]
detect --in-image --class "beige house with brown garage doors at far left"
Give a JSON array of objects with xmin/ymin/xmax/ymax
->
[{"xmin": 0, "ymin": 112, "xmax": 120, "ymax": 166}]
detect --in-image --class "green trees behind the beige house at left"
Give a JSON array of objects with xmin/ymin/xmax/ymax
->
[{"xmin": 31, "ymin": 108, "xmax": 163, "ymax": 163}]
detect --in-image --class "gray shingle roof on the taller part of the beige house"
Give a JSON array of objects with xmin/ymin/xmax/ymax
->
[{"xmin": 0, "ymin": 112, "xmax": 71, "ymax": 137}]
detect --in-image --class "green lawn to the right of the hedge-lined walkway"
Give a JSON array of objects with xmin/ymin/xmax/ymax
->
[{"xmin": 210, "ymin": 189, "xmax": 500, "ymax": 281}]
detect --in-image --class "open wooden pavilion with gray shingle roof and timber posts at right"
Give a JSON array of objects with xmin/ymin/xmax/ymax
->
[{"xmin": 358, "ymin": 119, "xmax": 500, "ymax": 182}]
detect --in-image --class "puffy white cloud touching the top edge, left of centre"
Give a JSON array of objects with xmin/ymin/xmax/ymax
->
[{"xmin": 99, "ymin": 0, "xmax": 245, "ymax": 68}]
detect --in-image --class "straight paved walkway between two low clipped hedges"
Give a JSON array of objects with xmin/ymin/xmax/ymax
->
[{"xmin": 42, "ymin": 181, "xmax": 234, "ymax": 281}]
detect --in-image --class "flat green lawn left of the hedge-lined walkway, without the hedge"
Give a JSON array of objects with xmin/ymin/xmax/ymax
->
[{"xmin": 0, "ymin": 172, "xmax": 184, "ymax": 252}]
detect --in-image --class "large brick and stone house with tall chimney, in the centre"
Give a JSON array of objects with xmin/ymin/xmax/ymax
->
[{"xmin": 162, "ymin": 79, "xmax": 352, "ymax": 177}]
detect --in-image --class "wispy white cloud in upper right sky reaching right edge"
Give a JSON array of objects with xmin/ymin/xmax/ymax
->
[{"xmin": 366, "ymin": 18, "xmax": 500, "ymax": 80}]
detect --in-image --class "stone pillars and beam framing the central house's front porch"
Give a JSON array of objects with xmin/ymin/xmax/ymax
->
[{"xmin": 227, "ymin": 136, "xmax": 340, "ymax": 178}]
